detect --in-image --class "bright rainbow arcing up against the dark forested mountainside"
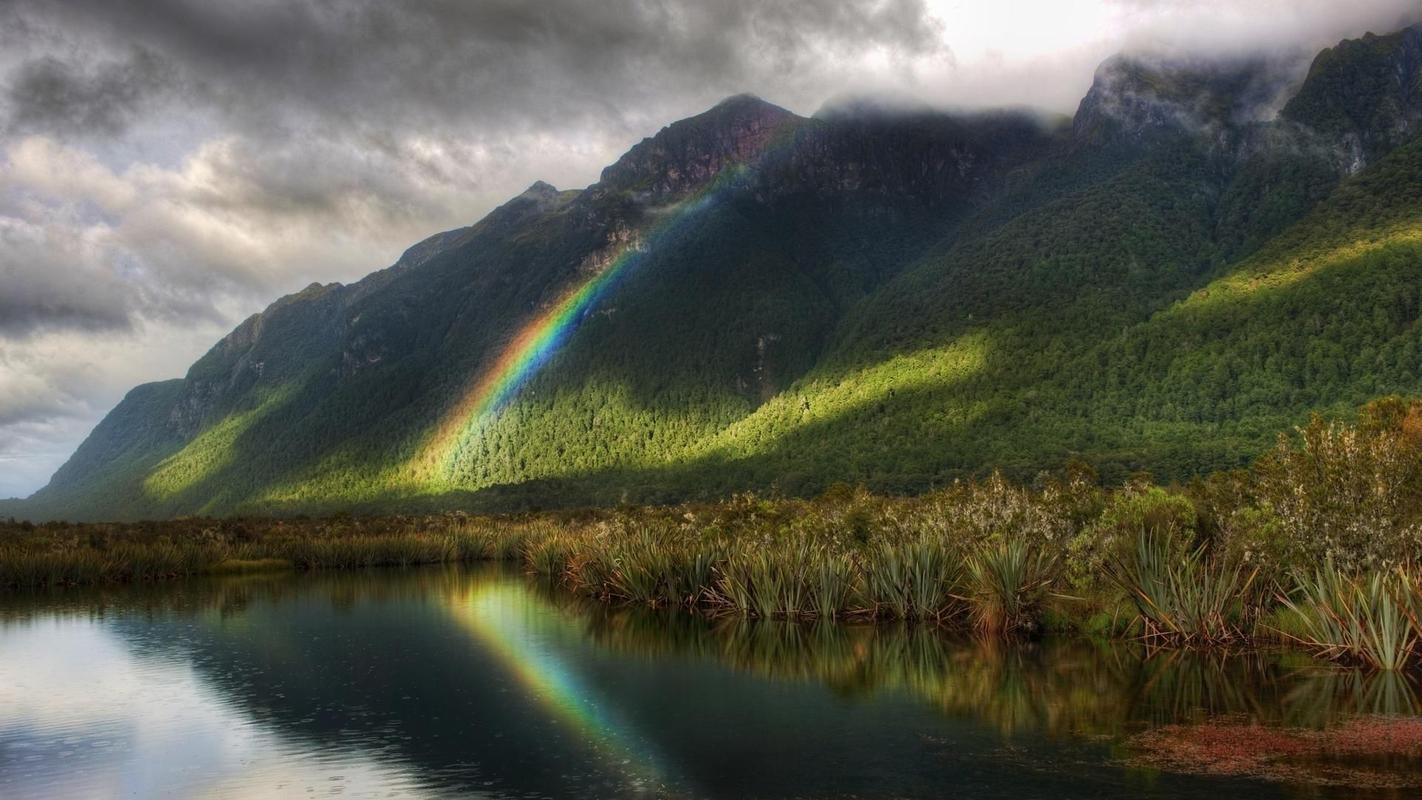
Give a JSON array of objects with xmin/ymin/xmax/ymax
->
[{"xmin": 417, "ymin": 118, "xmax": 793, "ymax": 477}]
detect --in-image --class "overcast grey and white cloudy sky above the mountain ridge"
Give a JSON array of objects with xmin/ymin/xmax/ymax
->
[{"xmin": 0, "ymin": 0, "xmax": 1418, "ymax": 497}]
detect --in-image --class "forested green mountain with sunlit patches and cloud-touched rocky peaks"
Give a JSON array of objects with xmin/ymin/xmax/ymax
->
[{"xmin": 13, "ymin": 28, "xmax": 1422, "ymax": 519}]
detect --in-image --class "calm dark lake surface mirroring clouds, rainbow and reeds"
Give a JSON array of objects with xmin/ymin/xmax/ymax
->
[{"xmin": 0, "ymin": 568, "xmax": 1418, "ymax": 800}]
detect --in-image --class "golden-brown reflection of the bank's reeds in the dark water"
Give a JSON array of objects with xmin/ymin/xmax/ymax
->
[{"xmin": 557, "ymin": 590, "xmax": 1422, "ymax": 737}]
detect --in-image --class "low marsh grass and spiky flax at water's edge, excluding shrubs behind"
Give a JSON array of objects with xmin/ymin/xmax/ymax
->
[{"xmin": 0, "ymin": 505, "xmax": 1422, "ymax": 671}]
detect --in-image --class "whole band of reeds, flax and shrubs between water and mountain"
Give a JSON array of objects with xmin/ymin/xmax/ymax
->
[{"xmin": 8, "ymin": 398, "xmax": 1422, "ymax": 671}]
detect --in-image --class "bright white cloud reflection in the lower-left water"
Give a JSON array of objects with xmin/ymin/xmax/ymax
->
[{"xmin": 0, "ymin": 605, "xmax": 432, "ymax": 799}]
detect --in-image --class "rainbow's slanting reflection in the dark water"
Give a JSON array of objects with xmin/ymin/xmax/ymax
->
[{"xmin": 447, "ymin": 581, "xmax": 663, "ymax": 789}]
